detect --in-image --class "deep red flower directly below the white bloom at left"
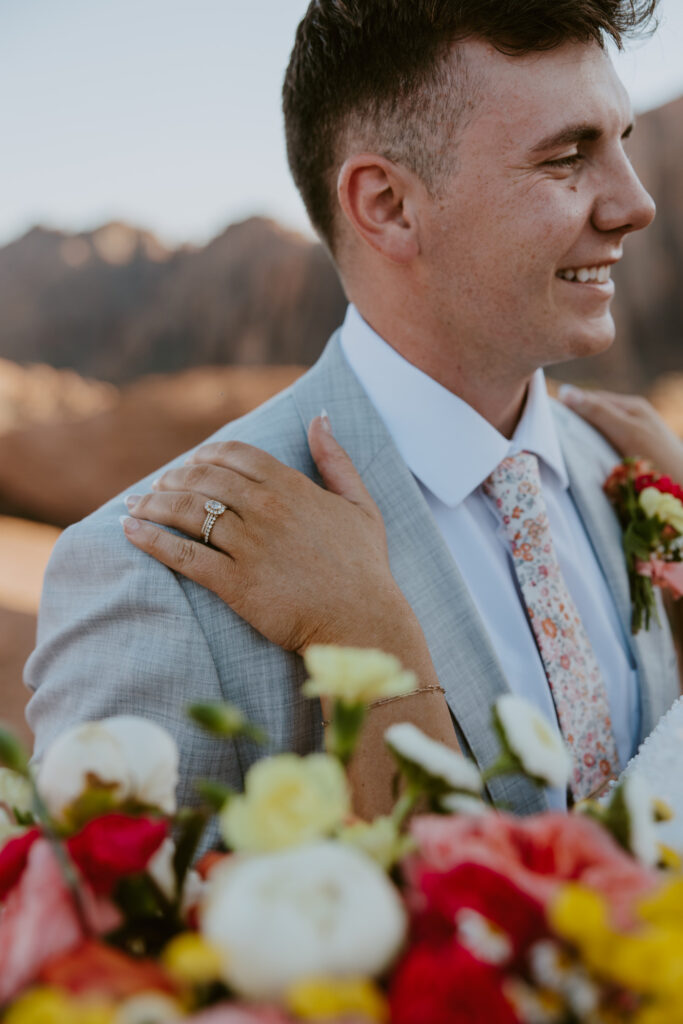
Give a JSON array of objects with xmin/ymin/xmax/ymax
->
[{"xmin": 67, "ymin": 814, "xmax": 168, "ymax": 895}]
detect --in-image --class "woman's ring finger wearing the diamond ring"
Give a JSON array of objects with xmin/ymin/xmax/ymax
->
[{"xmin": 126, "ymin": 490, "xmax": 243, "ymax": 554}]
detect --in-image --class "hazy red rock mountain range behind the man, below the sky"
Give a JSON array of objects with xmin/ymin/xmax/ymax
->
[{"xmin": 0, "ymin": 86, "xmax": 683, "ymax": 390}]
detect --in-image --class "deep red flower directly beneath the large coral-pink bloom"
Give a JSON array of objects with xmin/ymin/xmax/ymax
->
[{"xmin": 416, "ymin": 863, "xmax": 548, "ymax": 966}]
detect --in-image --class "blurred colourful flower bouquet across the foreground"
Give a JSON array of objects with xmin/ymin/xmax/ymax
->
[{"xmin": 0, "ymin": 648, "xmax": 683, "ymax": 1024}]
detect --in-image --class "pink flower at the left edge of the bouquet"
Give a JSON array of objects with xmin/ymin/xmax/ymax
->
[{"xmin": 0, "ymin": 839, "xmax": 121, "ymax": 1004}]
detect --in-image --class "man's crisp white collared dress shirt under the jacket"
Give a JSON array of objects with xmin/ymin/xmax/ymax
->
[{"xmin": 333, "ymin": 305, "xmax": 640, "ymax": 807}]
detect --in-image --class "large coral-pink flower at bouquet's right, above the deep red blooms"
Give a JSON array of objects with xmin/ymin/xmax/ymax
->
[{"xmin": 405, "ymin": 813, "xmax": 657, "ymax": 927}]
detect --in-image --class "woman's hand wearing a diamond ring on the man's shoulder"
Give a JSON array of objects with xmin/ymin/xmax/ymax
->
[{"xmin": 124, "ymin": 417, "xmax": 433, "ymax": 671}]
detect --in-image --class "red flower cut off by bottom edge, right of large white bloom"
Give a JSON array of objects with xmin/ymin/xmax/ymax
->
[{"xmin": 389, "ymin": 945, "xmax": 518, "ymax": 1024}]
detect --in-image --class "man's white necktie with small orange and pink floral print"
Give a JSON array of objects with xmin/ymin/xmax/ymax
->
[{"xmin": 483, "ymin": 452, "xmax": 618, "ymax": 800}]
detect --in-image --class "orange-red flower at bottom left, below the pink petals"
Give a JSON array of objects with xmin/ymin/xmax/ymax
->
[{"xmin": 38, "ymin": 939, "xmax": 174, "ymax": 999}]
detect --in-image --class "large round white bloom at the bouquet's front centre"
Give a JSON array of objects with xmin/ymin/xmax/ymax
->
[{"xmin": 201, "ymin": 840, "xmax": 407, "ymax": 999}]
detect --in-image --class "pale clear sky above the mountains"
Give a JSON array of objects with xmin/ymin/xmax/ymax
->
[{"xmin": 0, "ymin": 0, "xmax": 683, "ymax": 245}]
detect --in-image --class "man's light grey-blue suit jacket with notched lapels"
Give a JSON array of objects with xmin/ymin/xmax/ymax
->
[{"xmin": 26, "ymin": 336, "xmax": 678, "ymax": 813}]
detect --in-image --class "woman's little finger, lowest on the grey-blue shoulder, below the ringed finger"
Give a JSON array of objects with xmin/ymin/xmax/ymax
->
[{"xmin": 121, "ymin": 516, "xmax": 238, "ymax": 604}]
